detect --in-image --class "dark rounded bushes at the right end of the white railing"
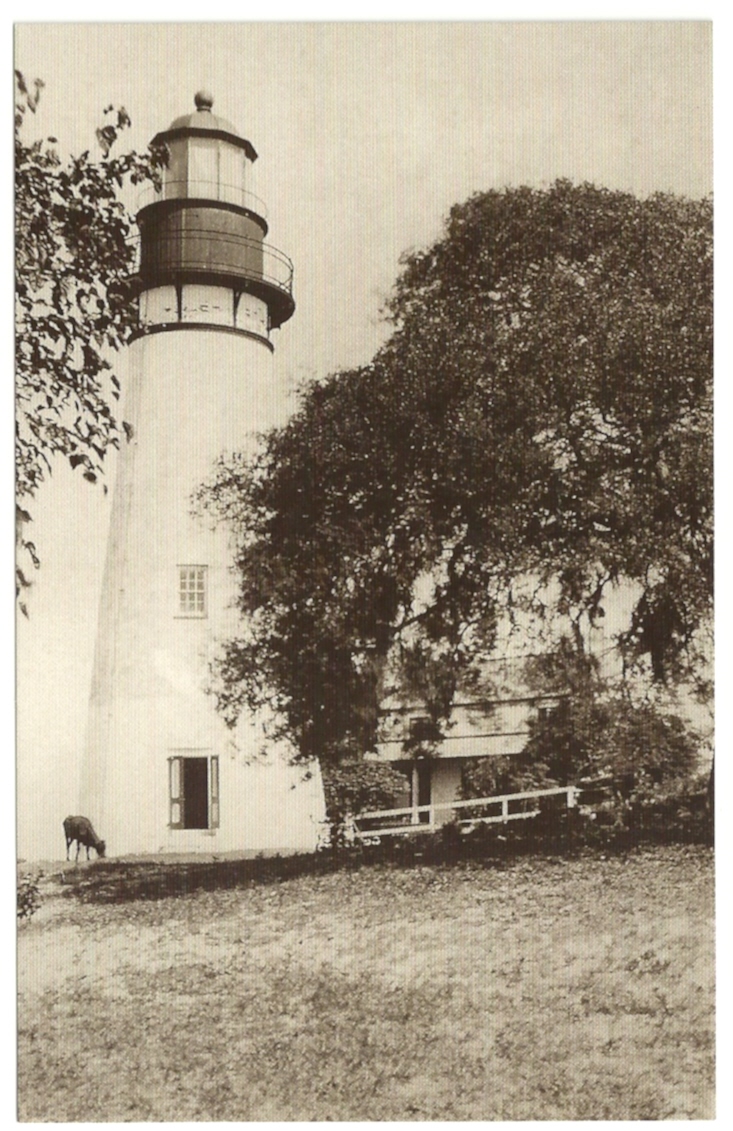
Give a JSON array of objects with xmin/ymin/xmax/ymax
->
[{"xmin": 462, "ymin": 689, "xmax": 714, "ymax": 852}]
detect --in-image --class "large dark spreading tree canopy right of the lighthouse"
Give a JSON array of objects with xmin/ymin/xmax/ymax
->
[{"xmin": 202, "ymin": 181, "xmax": 713, "ymax": 759}]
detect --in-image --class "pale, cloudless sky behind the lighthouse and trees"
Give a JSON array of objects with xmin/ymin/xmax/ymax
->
[{"xmin": 15, "ymin": 21, "xmax": 712, "ymax": 855}]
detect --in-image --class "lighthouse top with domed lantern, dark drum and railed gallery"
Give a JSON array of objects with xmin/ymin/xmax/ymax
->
[{"xmin": 136, "ymin": 92, "xmax": 295, "ymax": 342}]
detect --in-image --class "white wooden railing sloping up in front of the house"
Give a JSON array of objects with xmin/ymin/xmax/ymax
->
[{"xmin": 353, "ymin": 785, "xmax": 580, "ymax": 840}]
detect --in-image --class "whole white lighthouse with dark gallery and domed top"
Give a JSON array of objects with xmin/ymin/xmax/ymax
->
[{"xmin": 80, "ymin": 92, "xmax": 324, "ymax": 855}]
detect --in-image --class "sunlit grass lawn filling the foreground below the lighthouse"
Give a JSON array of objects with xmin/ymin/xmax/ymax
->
[{"xmin": 18, "ymin": 846, "xmax": 714, "ymax": 1122}]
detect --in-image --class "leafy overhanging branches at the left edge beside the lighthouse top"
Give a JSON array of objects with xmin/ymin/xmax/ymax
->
[{"xmin": 15, "ymin": 71, "xmax": 164, "ymax": 610}]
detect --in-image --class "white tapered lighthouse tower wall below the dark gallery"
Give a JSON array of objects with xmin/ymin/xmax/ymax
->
[{"xmin": 80, "ymin": 99, "xmax": 324, "ymax": 855}]
